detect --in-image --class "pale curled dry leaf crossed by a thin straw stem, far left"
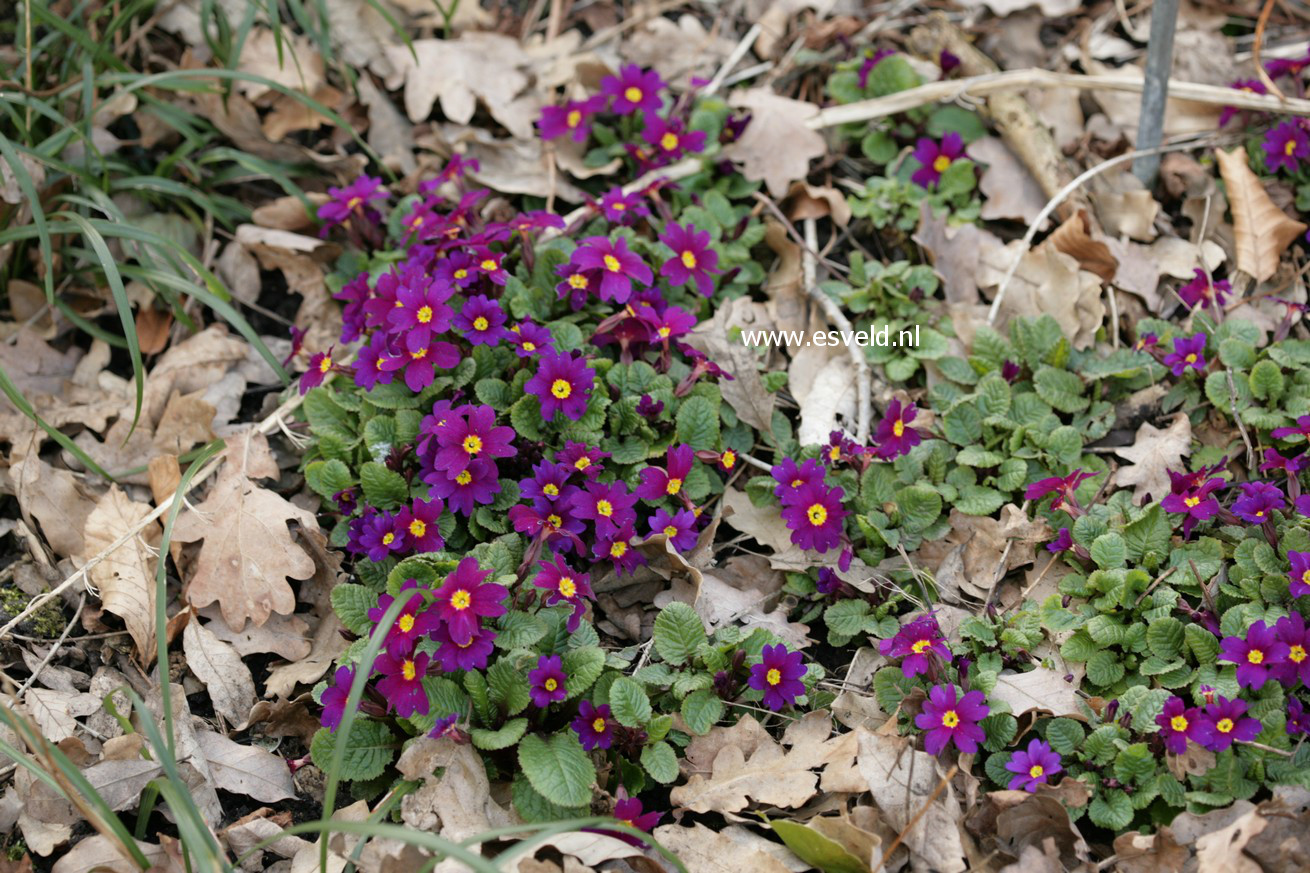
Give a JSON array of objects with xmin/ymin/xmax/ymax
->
[{"xmin": 83, "ymin": 485, "xmax": 161, "ymax": 663}]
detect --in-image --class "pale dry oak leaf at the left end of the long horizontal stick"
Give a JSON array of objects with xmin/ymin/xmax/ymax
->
[{"xmin": 723, "ymin": 88, "xmax": 828, "ymax": 199}]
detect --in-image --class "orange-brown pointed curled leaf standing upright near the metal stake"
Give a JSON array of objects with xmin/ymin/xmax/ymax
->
[{"xmin": 1214, "ymin": 147, "xmax": 1306, "ymax": 282}]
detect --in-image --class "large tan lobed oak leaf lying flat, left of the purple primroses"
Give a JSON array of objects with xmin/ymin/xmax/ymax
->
[{"xmin": 173, "ymin": 434, "xmax": 318, "ymax": 628}]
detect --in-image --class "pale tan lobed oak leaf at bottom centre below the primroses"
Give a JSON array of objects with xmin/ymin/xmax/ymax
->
[{"xmin": 671, "ymin": 712, "xmax": 854, "ymax": 813}]
